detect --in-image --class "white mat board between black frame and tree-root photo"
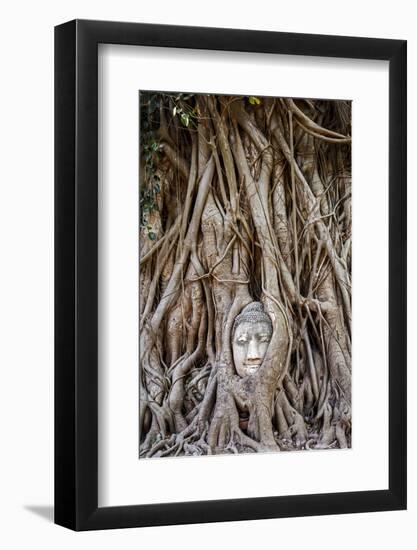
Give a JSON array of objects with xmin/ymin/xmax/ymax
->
[{"xmin": 99, "ymin": 45, "xmax": 388, "ymax": 506}]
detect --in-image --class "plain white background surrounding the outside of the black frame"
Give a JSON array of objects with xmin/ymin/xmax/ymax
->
[{"xmin": 0, "ymin": 0, "xmax": 417, "ymax": 550}]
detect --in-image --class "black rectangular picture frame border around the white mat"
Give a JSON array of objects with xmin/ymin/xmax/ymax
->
[{"xmin": 55, "ymin": 20, "xmax": 407, "ymax": 531}]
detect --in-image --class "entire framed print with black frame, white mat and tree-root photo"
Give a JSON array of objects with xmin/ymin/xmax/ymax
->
[{"xmin": 55, "ymin": 20, "xmax": 406, "ymax": 530}]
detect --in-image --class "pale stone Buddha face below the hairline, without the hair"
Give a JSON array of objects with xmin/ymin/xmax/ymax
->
[{"xmin": 232, "ymin": 321, "xmax": 272, "ymax": 378}]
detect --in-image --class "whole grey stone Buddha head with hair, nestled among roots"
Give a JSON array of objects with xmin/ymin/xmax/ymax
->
[{"xmin": 232, "ymin": 302, "xmax": 272, "ymax": 378}]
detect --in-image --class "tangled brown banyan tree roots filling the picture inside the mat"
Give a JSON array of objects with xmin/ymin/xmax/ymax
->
[{"xmin": 139, "ymin": 92, "xmax": 352, "ymax": 458}]
